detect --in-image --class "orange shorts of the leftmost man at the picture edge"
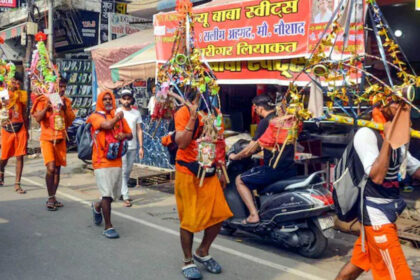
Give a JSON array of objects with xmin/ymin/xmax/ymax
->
[{"xmin": 1, "ymin": 126, "xmax": 28, "ymax": 160}]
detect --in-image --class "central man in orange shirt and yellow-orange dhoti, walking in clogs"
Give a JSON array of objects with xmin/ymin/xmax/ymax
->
[{"xmin": 175, "ymin": 92, "xmax": 232, "ymax": 279}]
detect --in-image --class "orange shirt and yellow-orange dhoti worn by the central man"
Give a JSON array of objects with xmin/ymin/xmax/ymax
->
[{"xmin": 175, "ymin": 106, "xmax": 233, "ymax": 232}]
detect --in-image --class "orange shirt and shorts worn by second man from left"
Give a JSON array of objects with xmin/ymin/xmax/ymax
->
[{"xmin": 31, "ymin": 95, "xmax": 75, "ymax": 166}]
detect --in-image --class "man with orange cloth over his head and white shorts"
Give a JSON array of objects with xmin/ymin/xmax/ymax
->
[{"xmin": 87, "ymin": 91, "xmax": 133, "ymax": 239}]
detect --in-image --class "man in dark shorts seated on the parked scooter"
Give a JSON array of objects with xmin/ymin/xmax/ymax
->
[{"xmin": 229, "ymin": 94, "xmax": 296, "ymax": 224}]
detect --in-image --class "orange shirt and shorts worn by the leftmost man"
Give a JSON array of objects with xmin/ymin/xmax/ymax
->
[{"xmin": 1, "ymin": 91, "xmax": 28, "ymax": 160}]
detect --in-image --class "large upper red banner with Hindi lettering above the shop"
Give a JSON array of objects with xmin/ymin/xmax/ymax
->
[{"xmin": 154, "ymin": 0, "xmax": 365, "ymax": 61}]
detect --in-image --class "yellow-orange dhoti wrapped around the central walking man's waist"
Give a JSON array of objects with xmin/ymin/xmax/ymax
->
[{"xmin": 175, "ymin": 171, "xmax": 233, "ymax": 232}]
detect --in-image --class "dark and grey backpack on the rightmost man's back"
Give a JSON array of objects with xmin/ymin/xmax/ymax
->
[{"xmin": 333, "ymin": 130, "xmax": 383, "ymax": 222}]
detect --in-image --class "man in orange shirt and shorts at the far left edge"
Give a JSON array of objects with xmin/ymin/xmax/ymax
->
[{"xmin": 0, "ymin": 79, "xmax": 28, "ymax": 194}]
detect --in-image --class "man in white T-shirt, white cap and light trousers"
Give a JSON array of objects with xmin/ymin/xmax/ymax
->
[{"xmin": 117, "ymin": 89, "xmax": 144, "ymax": 207}]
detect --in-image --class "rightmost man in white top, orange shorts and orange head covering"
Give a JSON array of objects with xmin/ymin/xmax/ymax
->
[{"xmin": 336, "ymin": 103, "xmax": 420, "ymax": 280}]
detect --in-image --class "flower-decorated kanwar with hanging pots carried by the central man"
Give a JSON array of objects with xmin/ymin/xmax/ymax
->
[{"xmin": 152, "ymin": 0, "xmax": 228, "ymax": 186}]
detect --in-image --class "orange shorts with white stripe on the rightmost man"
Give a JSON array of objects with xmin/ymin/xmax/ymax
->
[{"xmin": 351, "ymin": 224, "xmax": 413, "ymax": 280}]
